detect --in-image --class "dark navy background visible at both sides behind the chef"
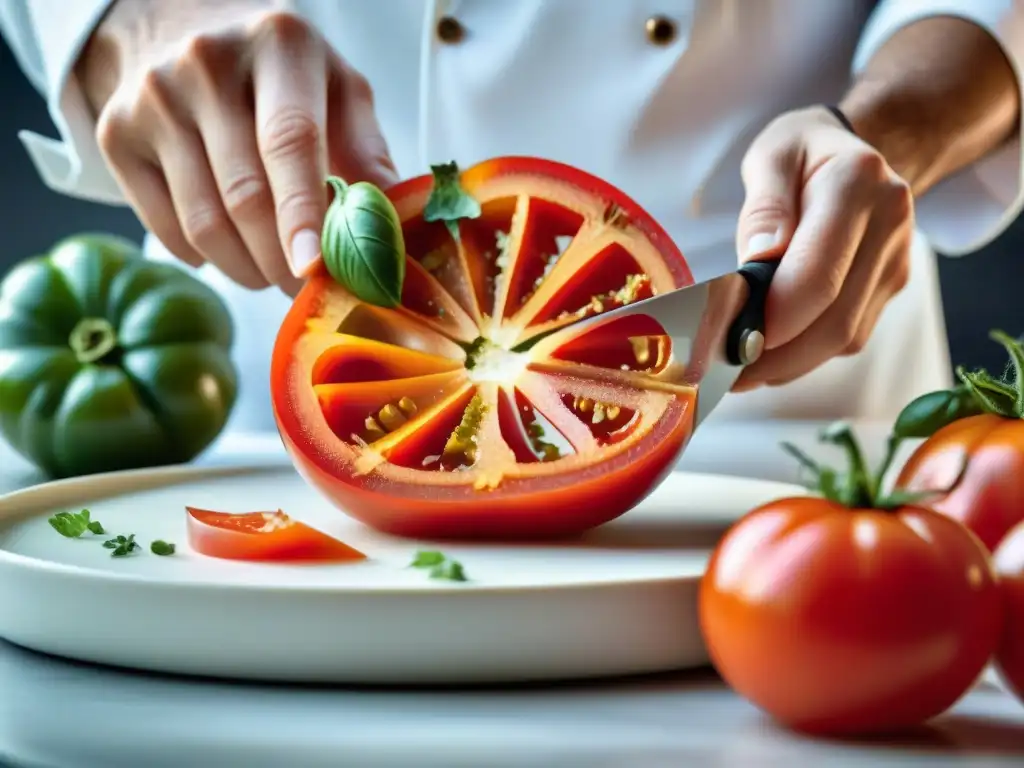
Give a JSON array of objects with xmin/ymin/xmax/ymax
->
[{"xmin": 0, "ymin": 38, "xmax": 1024, "ymax": 372}]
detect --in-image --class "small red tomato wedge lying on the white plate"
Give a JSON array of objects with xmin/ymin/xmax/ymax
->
[{"xmin": 185, "ymin": 507, "xmax": 367, "ymax": 562}]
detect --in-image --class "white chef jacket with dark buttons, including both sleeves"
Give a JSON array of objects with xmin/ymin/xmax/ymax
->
[{"xmin": 0, "ymin": 0, "xmax": 1024, "ymax": 436}]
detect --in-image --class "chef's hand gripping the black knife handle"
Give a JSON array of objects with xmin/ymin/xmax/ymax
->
[{"xmin": 734, "ymin": 108, "xmax": 913, "ymax": 391}]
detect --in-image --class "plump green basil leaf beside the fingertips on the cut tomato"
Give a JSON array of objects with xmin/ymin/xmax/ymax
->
[{"xmin": 321, "ymin": 176, "xmax": 406, "ymax": 307}]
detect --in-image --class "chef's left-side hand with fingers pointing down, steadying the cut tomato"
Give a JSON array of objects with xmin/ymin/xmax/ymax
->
[{"xmin": 77, "ymin": 0, "xmax": 396, "ymax": 294}]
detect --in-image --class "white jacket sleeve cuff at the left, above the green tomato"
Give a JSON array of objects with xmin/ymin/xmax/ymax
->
[{"xmin": 0, "ymin": 0, "xmax": 124, "ymax": 204}]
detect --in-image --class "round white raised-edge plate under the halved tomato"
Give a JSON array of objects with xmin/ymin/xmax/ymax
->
[{"xmin": 0, "ymin": 463, "xmax": 806, "ymax": 684}]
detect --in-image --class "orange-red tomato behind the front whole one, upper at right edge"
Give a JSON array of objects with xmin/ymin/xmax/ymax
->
[{"xmin": 897, "ymin": 414, "xmax": 1024, "ymax": 551}]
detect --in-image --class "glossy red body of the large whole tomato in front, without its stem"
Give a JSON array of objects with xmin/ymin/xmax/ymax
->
[{"xmin": 699, "ymin": 498, "xmax": 1002, "ymax": 733}]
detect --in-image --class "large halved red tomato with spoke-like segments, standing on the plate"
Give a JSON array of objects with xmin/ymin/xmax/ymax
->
[{"xmin": 271, "ymin": 158, "xmax": 696, "ymax": 539}]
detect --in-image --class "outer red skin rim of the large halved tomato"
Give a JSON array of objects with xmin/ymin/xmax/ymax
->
[{"xmin": 271, "ymin": 158, "xmax": 694, "ymax": 540}]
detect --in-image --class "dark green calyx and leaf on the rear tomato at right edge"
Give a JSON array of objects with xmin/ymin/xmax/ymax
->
[{"xmin": 893, "ymin": 331, "xmax": 1024, "ymax": 439}]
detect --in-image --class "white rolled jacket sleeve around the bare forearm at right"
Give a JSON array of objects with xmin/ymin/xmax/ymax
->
[{"xmin": 853, "ymin": 0, "xmax": 1024, "ymax": 256}]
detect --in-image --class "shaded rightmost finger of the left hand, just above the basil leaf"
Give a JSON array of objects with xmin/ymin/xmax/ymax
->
[{"xmin": 328, "ymin": 56, "xmax": 398, "ymax": 189}]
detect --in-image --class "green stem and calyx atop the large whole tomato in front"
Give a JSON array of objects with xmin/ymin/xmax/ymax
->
[{"xmin": 782, "ymin": 422, "xmax": 963, "ymax": 511}]
